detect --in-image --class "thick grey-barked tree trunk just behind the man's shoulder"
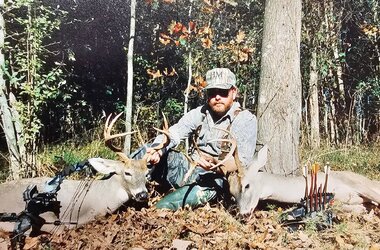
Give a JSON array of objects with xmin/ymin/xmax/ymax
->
[{"xmin": 257, "ymin": 0, "xmax": 302, "ymax": 175}]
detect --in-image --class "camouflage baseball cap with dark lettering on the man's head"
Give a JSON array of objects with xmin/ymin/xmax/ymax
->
[{"xmin": 205, "ymin": 68, "xmax": 236, "ymax": 89}]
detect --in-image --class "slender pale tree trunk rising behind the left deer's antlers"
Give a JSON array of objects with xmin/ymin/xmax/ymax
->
[{"xmin": 124, "ymin": 0, "xmax": 136, "ymax": 155}]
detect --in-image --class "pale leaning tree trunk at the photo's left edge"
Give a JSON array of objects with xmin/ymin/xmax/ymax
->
[{"xmin": 0, "ymin": 4, "xmax": 22, "ymax": 180}]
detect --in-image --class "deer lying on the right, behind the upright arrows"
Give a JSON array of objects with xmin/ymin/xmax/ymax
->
[{"xmin": 228, "ymin": 146, "xmax": 380, "ymax": 214}]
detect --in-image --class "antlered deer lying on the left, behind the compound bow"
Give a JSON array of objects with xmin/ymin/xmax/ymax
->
[{"xmin": 0, "ymin": 114, "xmax": 170, "ymax": 232}]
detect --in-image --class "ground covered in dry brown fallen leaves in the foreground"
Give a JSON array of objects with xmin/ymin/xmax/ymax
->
[{"xmin": 0, "ymin": 186, "xmax": 380, "ymax": 250}]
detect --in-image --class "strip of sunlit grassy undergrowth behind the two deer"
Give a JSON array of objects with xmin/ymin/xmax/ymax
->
[{"xmin": 0, "ymin": 129, "xmax": 380, "ymax": 180}]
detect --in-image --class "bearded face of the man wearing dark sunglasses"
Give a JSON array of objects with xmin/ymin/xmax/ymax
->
[{"xmin": 207, "ymin": 87, "xmax": 237, "ymax": 117}]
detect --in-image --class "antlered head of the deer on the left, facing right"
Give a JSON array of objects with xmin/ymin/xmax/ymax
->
[{"xmin": 89, "ymin": 113, "xmax": 170, "ymax": 201}]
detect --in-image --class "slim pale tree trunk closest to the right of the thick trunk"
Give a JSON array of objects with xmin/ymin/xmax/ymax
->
[{"xmin": 309, "ymin": 48, "xmax": 321, "ymax": 149}]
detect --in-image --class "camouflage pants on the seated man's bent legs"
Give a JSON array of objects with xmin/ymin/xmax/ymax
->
[{"xmin": 131, "ymin": 146, "xmax": 226, "ymax": 210}]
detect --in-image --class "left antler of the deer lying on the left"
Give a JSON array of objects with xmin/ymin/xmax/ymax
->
[{"xmin": 104, "ymin": 112, "xmax": 134, "ymax": 162}]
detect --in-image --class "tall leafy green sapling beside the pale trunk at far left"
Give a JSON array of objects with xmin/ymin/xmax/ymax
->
[{"xmin": 5, "ymin": 0, "xmax": 66, "ymax": 153}]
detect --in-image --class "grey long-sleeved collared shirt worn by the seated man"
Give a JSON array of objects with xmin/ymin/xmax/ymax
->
[{"xmin": 154, "ymin": 102, "xmax": 257, "ymax": 167}]
